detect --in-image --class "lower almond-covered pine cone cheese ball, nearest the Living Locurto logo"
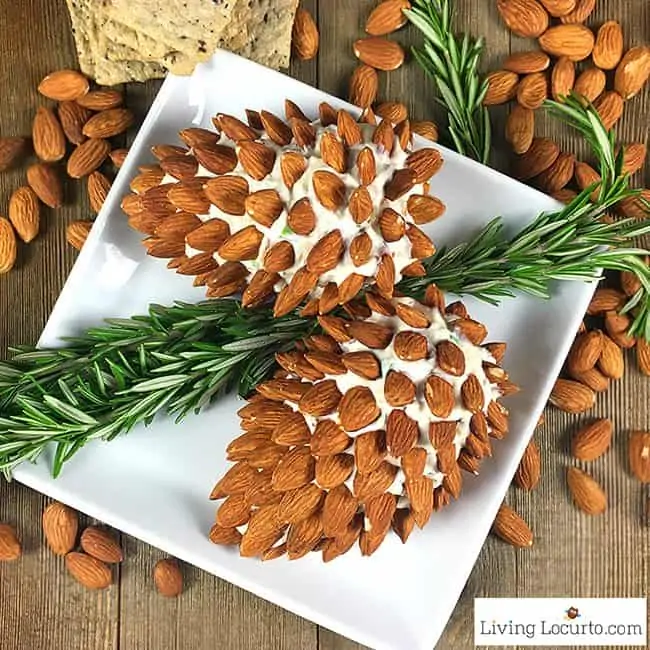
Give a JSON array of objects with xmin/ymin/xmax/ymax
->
[{"xmin": 210, "ymin": 292, "xmax": 513, "ymax": 562}]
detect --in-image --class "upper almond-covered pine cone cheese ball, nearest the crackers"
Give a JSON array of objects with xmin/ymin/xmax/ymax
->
[{"xmin": 122, "ymin": 102, "xmax": 445, "ymax": 316}]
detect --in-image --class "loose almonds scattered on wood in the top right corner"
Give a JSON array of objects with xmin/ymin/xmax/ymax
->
[{"xmin": 484, "ymin": 0, "xmax": 650, "ymax": 218}]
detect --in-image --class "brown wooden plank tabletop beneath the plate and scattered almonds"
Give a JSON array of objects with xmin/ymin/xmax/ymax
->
[{"xmin": 0, "ymin": 0, "xmax": 650, "ymax": 650}]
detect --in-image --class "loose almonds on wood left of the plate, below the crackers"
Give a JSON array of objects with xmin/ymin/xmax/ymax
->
[{"xmin": 0, "ymin": 70, "xmax": 134, "ymax": 273}]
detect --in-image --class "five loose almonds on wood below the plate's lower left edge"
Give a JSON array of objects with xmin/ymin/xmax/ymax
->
[{"xmin": 0, "ymin": 501, "xmax": 183, "ymax": 597}]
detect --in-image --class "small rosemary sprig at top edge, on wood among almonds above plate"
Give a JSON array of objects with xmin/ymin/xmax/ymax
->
[{"xmin": 404, "ymin": 0, "xmax": 491, "ymax": 164}]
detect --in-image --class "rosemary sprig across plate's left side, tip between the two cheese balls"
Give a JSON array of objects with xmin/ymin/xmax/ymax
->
[{"xmin": 0, "ymin": 299, "xmax": 315, "ymax": 477}]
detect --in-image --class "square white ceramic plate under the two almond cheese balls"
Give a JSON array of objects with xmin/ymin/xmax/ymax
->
[{"xmin": 16, "ymin": 52, "xmax": 593, "ymax": 650}]
